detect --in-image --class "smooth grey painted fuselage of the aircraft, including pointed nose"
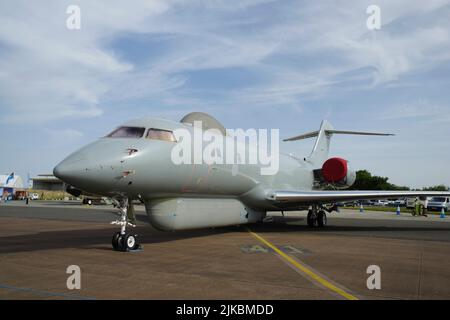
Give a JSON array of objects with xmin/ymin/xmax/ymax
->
[{"xmin": 54, "ymin": 119, "xmax": 314, "ymax": 210}]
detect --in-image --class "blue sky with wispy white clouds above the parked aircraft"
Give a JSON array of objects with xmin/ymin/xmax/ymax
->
[{"xmin": 0, "ymin": 0, "xmax": 450, "ymax": 187}]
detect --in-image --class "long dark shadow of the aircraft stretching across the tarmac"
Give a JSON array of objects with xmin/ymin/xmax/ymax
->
[{"xmin": 0, "ymin": 215, "xmax": 448, "ymax": 254}]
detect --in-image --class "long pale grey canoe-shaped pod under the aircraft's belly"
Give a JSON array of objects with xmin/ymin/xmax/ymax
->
[{"xmin": 145, "ymin": 198, "xmax": 266, "ymax": 231}]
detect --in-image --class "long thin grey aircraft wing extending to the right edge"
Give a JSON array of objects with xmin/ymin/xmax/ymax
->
[{"xmin": 267, "ymin": 190, "xmax": 450, "ymax": 203}]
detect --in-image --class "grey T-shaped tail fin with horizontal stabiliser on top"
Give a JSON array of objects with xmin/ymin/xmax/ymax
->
[{"xmin": 283, "ymin": 120, "xmax": 394, "ymax": 166}]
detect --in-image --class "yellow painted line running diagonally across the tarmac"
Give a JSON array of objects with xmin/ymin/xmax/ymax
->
[{"xmin": 247, "ymin": 228, "xmax": 358, "ymax": 300}]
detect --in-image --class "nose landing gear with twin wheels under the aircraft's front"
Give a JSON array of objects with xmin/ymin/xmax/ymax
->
[{"xmin": 111, "ymin": 198, "xmax": 141, "ymax": 251}]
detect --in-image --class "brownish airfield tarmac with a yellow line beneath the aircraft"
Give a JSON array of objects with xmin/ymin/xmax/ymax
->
[{"xmin": 0, "ymin": 201, "xmax": 450, "ymax": 299}]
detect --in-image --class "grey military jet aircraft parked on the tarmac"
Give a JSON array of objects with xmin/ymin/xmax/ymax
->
[{"xmin": 53, "ymin": 112, "xmax": 450, "ymax": 251}]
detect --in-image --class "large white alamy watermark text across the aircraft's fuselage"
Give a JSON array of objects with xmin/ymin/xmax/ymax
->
[{"xmin": 171, "ymin": 121, "xmax": 280, "ymax": 175}]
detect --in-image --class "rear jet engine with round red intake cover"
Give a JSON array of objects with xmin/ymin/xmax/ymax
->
[{"xmin": 314, "ymin": 157, "xmax": 356, "ymax": 189}]
